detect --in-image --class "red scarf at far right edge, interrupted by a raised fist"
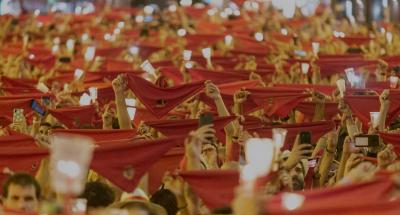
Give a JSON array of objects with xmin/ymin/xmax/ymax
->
[{"xmin": 344, "ymin": 91, "xmax": 400, "ymax": 130}]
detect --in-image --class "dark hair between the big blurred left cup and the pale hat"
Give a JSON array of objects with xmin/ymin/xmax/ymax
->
[{"xmin": 80, "ymin": 181, "xmax": 115, "ymax": 208}]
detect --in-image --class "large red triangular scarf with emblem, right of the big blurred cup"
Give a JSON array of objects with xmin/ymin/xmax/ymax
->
[{"xmin": 91, "ymin": 136, "xmax": 184, "ymax": 192}]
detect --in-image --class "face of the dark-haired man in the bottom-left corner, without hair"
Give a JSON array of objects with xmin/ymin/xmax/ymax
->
[{"xmin": 4, "ymin": 184, "xmax": 39, "ymax": 212}]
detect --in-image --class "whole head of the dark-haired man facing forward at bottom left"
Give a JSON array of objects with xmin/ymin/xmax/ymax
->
[{"xmin": 3, "ymin": 173, "xmax": 41, "ymax": 212}]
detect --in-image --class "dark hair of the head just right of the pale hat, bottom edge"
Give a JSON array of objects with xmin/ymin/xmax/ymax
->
[{"xmin": 150, "ymin": 189, "xmax": 179, "ymax": 215}]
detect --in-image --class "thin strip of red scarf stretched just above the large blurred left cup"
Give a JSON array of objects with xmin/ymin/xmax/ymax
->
[{"xmin": 51, "ymin": 129, "xmax": 136, "ymax": 142}]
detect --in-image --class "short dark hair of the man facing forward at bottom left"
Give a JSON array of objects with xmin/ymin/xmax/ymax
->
[{"xmin": 3, "ymin": 173, "xmax": 41, "ymax": 199}]
